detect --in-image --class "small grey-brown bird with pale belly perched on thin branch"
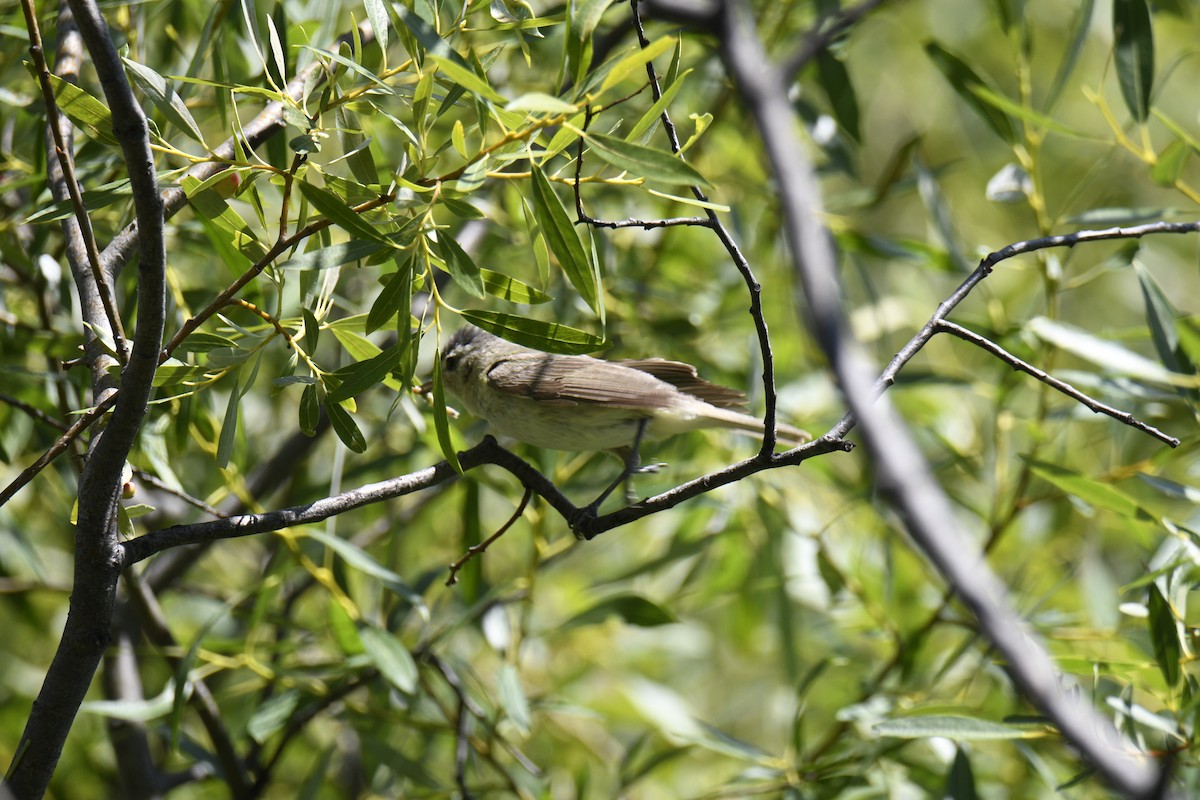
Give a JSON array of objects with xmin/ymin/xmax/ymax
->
[{"xmin": 442, "ymin": 326, "xmax": 812, "ymax": 453}]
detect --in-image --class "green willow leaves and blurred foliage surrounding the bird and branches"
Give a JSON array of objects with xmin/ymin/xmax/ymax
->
[{"xmin": 0, "ymin": 0, "xmax": 1200, "ymax": 798}]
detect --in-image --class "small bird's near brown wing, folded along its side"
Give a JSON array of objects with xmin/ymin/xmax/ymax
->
[{"xmin": 487, "ymin": 353, "xmax": 679, "ymax": 410}]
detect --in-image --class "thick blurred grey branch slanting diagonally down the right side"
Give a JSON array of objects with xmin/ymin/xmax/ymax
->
[{"xmin": 705, "ymin": 0, "xmax": 1165, "ymax": 798}]
